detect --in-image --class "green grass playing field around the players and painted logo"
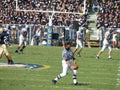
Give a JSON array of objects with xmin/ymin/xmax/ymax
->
[{"xmin": 0, "ymin": 46, "xmax": 120, "ymax": 90}]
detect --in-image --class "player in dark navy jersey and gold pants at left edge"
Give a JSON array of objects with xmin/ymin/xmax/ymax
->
[{"xmin": 0, "ymin": 27, "xmax": 14, "ymax": 64}]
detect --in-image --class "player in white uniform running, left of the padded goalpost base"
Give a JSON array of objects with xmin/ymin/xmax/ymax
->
[{"xmin": 15, "ymin": 28, "xmax": 27, "ymax": 53}]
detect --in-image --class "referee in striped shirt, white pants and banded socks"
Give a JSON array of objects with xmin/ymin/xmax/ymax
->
[{"xmin": 52, "ymin": 43, "xmax": 78, "ymax": 85}]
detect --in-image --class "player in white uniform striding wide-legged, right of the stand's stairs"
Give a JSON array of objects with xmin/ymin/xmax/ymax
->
[{"xmin": 96, "ymin": 30, "xmax": 114, "ymax": 59}]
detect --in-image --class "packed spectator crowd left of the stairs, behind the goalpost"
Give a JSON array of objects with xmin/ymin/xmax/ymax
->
[{"xmin": 0, "ymin": 0, "xmax": 89, "ymax": 26}]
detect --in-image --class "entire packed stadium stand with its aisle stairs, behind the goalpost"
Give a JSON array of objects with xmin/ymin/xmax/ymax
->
[{"xmin": 0, "ymin": 0, "xmax": 120, "ymax": 47}]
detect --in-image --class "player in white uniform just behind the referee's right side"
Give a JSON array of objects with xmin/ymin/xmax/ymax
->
[{"xmin": 73, "ymin": 29, "xmax": 83, "ymax": 56}]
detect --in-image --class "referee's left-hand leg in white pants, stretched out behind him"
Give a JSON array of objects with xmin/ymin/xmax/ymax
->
[{"xmin": 52, "ymin": 60, "xmax": 68, "ymax": 84}]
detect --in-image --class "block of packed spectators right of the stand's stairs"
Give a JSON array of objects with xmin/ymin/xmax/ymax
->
[{"xmin": 95, "ymin": 0, "xmax": 120, "ymax": 29}]
